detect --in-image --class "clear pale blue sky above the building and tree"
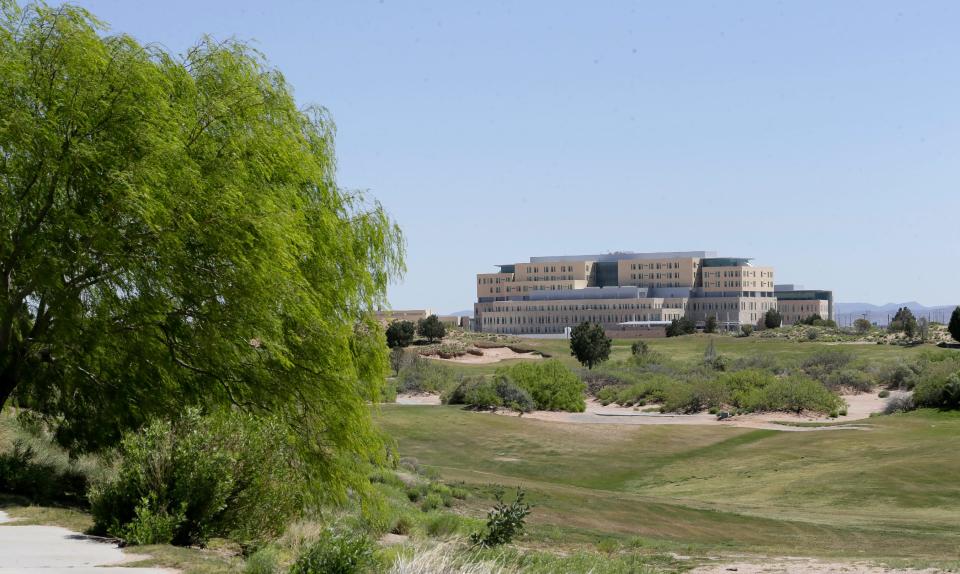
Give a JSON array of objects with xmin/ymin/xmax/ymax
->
[{"xmin": 58, "ymin": 0, "xmax": 960, "ymax": 312}]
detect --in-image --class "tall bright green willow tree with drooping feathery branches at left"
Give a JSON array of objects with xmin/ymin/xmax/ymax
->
[{"xmin": 0, "ymin": 0, "xmax": 403, "ymax": 500}]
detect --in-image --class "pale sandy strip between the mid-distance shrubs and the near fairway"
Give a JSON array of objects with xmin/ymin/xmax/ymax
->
[{"xmin": 397, "ymin": 392, "xmax": 898, "ymax": 432}]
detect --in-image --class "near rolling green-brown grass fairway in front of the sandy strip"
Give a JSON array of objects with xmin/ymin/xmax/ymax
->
[{"xmin": 378, "ymin": 408, "xmax": 960, "ymax": 563}]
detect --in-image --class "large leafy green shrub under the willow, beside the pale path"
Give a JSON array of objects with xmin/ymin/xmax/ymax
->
[{"xmin": 90, "ymin": 410, "xmax": 304, "ymax": 545}]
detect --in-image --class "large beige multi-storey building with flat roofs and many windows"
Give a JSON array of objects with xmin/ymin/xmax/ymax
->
[{"xmin": 474, "ymin": 251, "xmax": 833, "ymax": 334}]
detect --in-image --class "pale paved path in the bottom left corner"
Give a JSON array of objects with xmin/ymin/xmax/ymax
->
[{"xmin": 0, "ymin": 511, "xmax": 177, "ymax": 574}]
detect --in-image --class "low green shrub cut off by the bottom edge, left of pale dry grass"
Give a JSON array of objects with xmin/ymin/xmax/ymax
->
[{"xmin": 290, "ymin": 528, "xmax": 374, "ymax": 574}]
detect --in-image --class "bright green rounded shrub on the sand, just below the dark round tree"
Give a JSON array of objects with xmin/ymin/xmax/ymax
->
[{"xmin": 497, "ymin": 361, "xmax": 587, "ymax": 412}]
